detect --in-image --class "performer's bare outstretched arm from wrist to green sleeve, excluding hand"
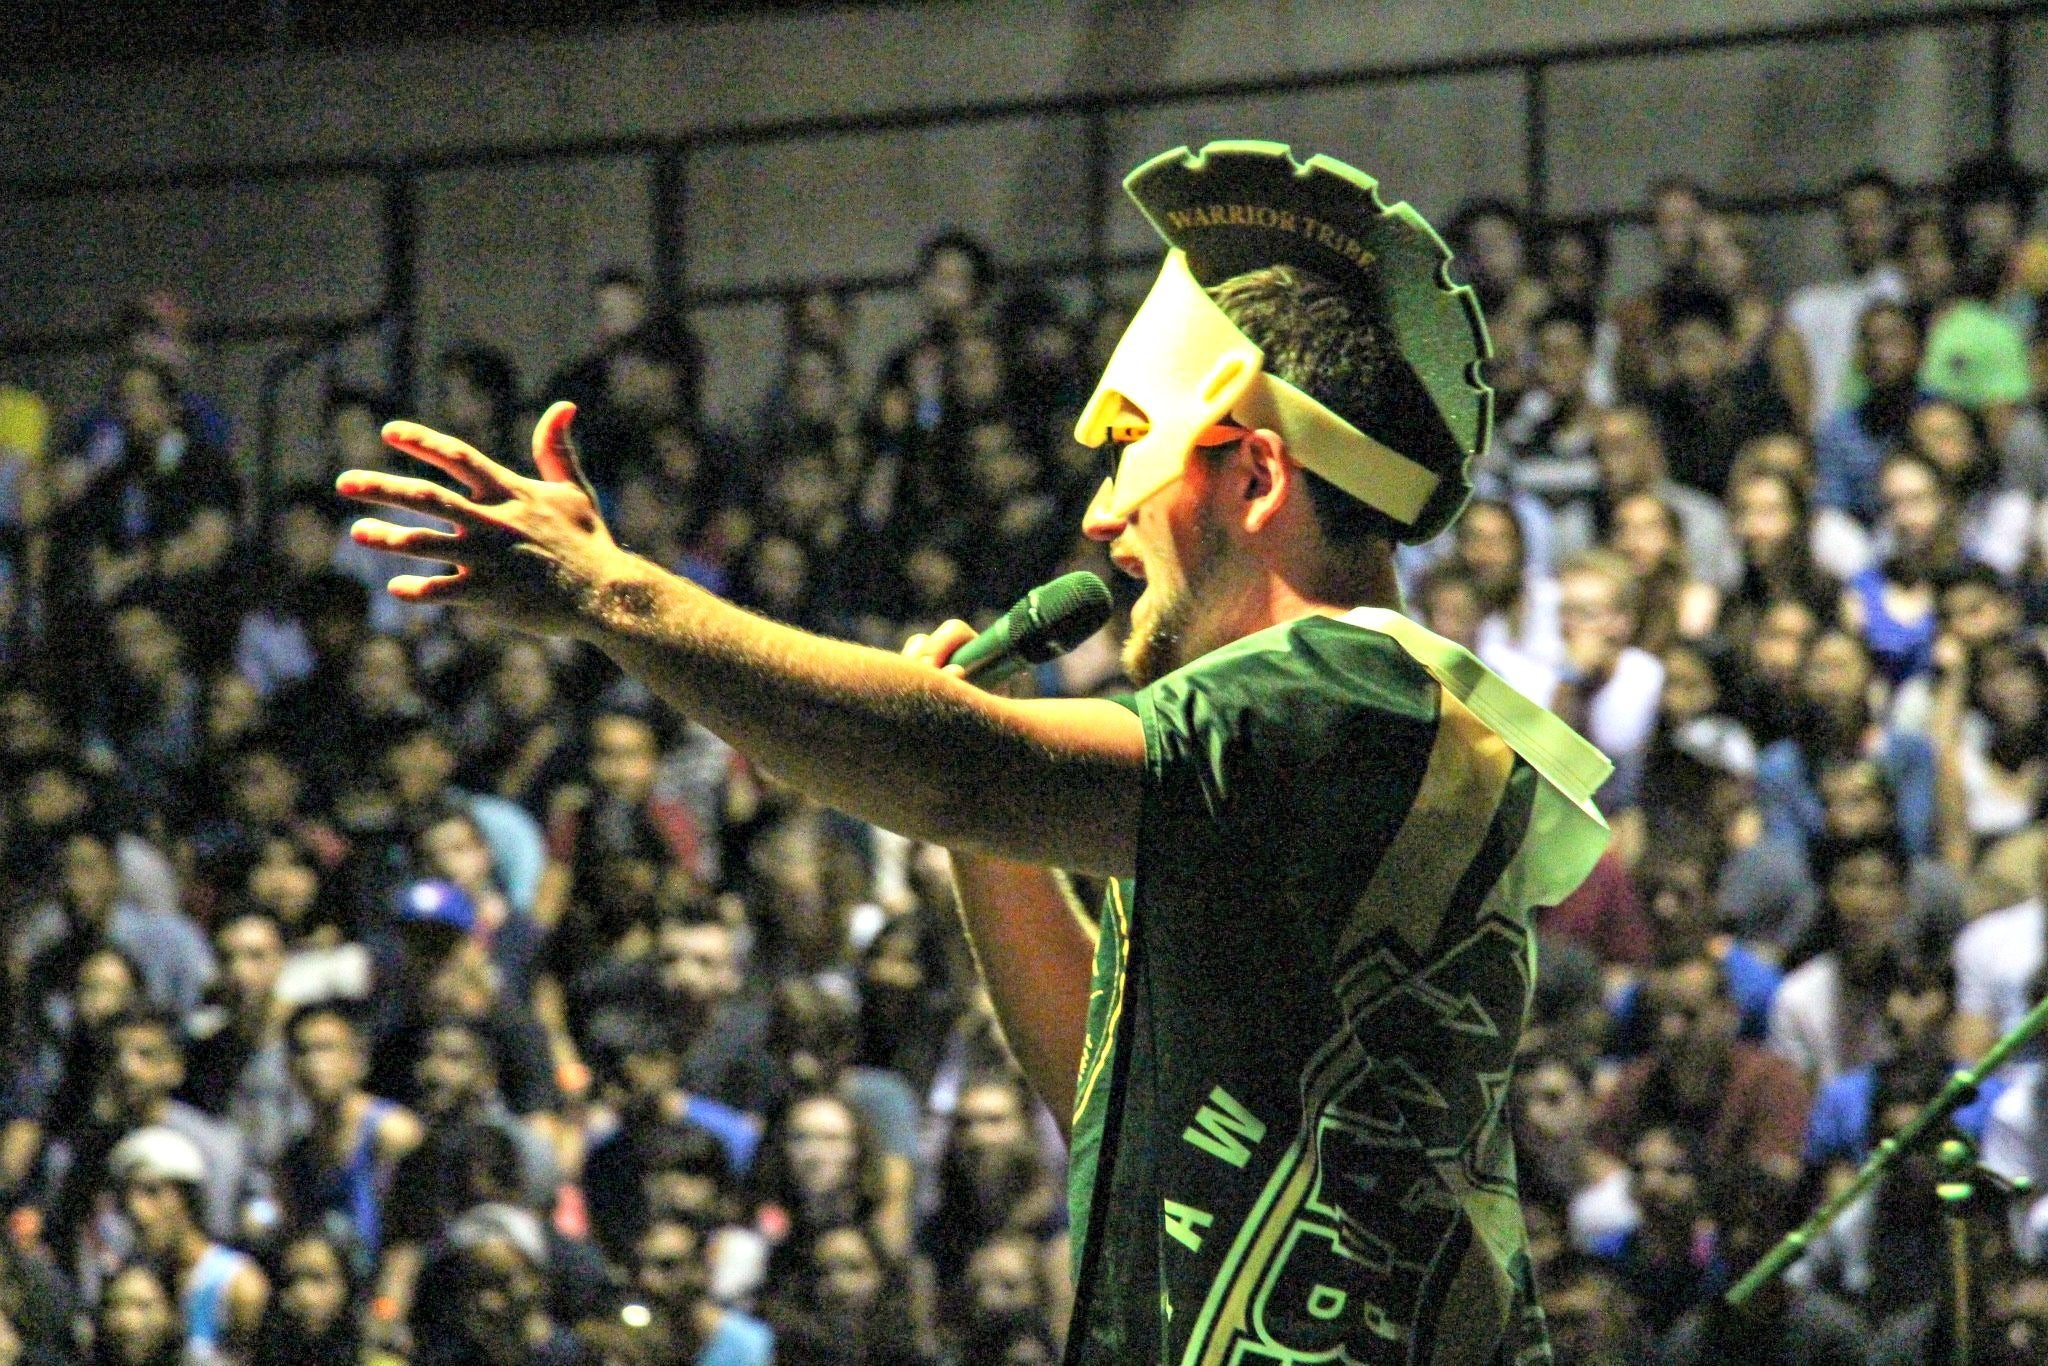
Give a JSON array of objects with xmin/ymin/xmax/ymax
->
[{"xmin": 586, "ymin": 559, "xmax": 1143, "ymax": 874}]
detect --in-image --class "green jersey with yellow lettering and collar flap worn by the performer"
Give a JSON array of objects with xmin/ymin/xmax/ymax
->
[{"xmin": 1069, "ymin": 608, "xmax": 1608, "ymax": 1366}]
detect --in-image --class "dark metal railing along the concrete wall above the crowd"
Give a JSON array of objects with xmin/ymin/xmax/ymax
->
[{"xmin": 0, "ymin": 0, "xmax": 2048, "ymax": 491}]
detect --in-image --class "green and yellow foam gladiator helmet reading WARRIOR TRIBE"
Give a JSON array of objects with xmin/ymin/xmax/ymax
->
[{"xmin": 1075, "ymin": 141, "xmax": 1493, "ymax": 543}]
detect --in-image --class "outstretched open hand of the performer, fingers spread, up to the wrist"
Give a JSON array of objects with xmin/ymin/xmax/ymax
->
[{"xmin": 334, "ymin": 403, "xmax": 627, "ymax": 635}]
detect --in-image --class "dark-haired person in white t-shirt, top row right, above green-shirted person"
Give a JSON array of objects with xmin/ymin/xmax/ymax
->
[{"xmin": 1786, "ymin": 168, "xmax": 1907, "ymax": 430}]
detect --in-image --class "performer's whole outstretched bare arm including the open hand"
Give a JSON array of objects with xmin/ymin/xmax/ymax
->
[{"xmin": 338, "ymin": 403, "xmax": 1145, "ymax": 874}]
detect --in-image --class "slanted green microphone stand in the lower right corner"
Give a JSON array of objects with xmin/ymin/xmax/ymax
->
[{"xmin": 1726, "ymin": 995, "xmax": 2048, "ymax": 1366}]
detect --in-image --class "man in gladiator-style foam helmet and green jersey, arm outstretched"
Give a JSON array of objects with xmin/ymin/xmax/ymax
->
[{"xmin": 340, "ymin": 141, "xmax": 1608, "ymax": 1366}]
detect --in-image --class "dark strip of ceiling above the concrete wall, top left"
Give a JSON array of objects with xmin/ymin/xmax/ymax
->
[{"xmin": 0, "ymin": 0, "xmax": 915, "ymax": 76}]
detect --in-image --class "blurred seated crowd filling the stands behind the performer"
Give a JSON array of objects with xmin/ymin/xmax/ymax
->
[{"xmin": 0, "ymin": 144, "xmax": 2048, "ymax": 1366}]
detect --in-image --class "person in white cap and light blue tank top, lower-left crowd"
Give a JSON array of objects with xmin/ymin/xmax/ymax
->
[{"xmin": 106, "ymin": 1124, "xmax": 270, "ymax": 1360}]
